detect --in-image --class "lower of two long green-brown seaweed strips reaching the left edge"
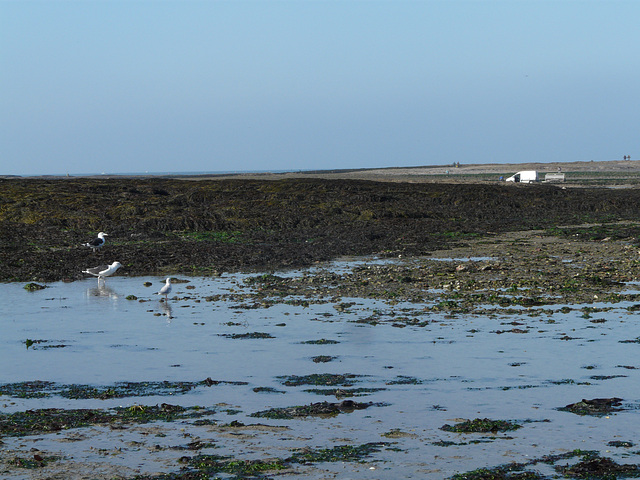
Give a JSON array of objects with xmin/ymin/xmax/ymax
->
[{"xmin": 0, "ymin": 403, "xmax": 215, "ymax": 437}]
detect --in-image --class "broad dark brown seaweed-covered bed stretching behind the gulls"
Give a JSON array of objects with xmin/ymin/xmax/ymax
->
[{"xmin": 0, "ymin": 178, "xmax": 640, "ymax": 281}]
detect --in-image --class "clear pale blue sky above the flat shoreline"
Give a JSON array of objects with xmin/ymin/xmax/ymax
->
[{"xmin": 0, "ymin": 0, "xmax": 640, "ymax": 175}]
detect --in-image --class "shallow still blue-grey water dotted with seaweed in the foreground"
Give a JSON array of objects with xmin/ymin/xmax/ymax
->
[{"xmin": 0, "ymin": 263, "xmax": 640, "ymax": 479}]
